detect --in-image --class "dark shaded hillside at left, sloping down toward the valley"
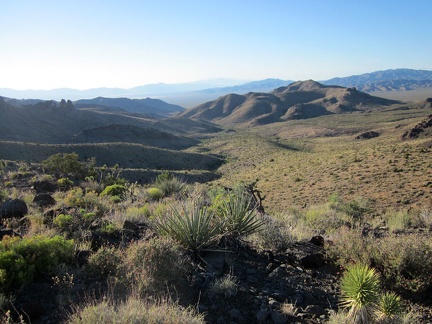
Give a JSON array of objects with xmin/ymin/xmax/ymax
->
[{"xmin": 0, "ymin": 97, "xmax": 217, "ymax": 149}]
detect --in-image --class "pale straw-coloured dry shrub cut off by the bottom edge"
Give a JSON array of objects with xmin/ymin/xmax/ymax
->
[{"xmin": 67, "ymin": 297, "xmax": 205, "ymax": 324}]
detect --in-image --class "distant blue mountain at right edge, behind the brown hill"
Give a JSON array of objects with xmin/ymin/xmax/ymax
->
[{"xmin": 323, "ymin": 69, "xmax": 432, "ymax": 92}]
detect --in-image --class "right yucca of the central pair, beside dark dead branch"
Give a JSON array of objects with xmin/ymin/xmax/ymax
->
[{"xmin": 218, "ymin": 190, "xmax": 265, "ymax": 236}]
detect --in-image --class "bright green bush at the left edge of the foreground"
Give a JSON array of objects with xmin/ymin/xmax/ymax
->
[{"xmin": 0, "ymin": 235, "xmax": 74, "ymax": 289}]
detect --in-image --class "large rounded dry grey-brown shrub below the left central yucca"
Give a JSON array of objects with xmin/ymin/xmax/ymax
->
[{"xmin": 122, "ymin": 237, "xmax": 191, "ymax": 294}]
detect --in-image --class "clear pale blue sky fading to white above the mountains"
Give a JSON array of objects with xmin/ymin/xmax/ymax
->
[{"xmin": 0, "ymin": 0, "xmax": 432, "ymax": 89}]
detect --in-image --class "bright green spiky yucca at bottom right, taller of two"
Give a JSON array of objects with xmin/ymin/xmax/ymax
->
[{"xmin": 341, "ymin": 264, "xmax": 380, "ymax": 324}]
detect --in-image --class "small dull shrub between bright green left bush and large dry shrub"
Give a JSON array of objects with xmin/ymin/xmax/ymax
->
[{"xmin": 86, "ymin": 246, "xmax": 122, "ymax": 278}]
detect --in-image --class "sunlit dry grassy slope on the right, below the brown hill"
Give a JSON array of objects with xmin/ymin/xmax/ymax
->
[{"xmin": 204, "ymin": 109, "xmax": 432, "ymax": 213}]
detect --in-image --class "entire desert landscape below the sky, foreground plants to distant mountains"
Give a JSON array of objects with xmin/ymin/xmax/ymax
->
[{"xmin": 0, "ymin": 69, "xmax": 432, "ymax": 324}]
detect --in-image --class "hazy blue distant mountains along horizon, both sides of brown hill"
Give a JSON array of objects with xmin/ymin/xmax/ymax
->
[{"xmin": 0, "ymin": 69, "xmax": 432, "ymax": 108}]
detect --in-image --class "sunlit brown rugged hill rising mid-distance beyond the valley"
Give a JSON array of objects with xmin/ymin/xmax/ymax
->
[{"xmin": 179, "ymin": 80, "xmax": 398, "ymax": 125}]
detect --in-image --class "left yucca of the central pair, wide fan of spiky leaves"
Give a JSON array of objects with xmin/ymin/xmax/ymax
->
[{"xmin": 155, "ymin": 203, "xmax": 220, "ymax": 252}]
